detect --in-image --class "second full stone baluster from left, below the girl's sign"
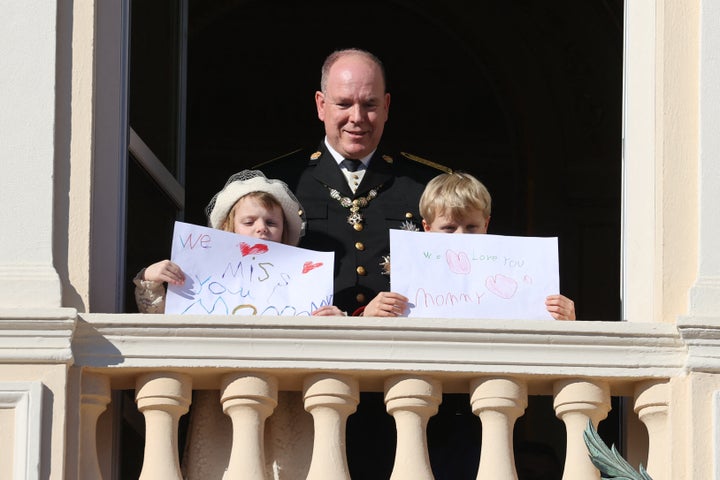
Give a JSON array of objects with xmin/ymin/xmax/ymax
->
[{"xmin": 220, "ymin": 373, "xmax": 278, "ymax": 480}]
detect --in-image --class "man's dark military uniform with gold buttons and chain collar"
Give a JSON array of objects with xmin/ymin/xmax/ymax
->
[{"xmin": 255, "ymin": 142, "xmax": 449, "ymax": 313}]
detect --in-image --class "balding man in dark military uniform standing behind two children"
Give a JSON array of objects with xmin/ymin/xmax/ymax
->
[{"xmin": 258, "ymin": 49, "xmax": 449, "ymax": 316}]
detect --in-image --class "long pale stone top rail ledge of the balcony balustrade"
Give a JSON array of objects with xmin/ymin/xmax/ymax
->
[{"xmin": 73, "ymin": 314, "xmax": 687, "ymax": 390}]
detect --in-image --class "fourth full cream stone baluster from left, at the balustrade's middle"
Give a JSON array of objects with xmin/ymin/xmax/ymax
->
[{"xmin": 385, "ymin": 375, "xmax": 442, "ymax": 480}]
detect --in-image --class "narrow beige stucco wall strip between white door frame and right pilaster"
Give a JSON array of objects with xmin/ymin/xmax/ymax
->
[{"xmin": 656, "ymin": 1, "xmax": 699, "ymax": 323}]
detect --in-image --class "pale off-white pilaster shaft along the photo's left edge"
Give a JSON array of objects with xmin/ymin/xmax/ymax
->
[{"xmin": 0, "ymin": 0, "xmax": 60, "ymax": 308}]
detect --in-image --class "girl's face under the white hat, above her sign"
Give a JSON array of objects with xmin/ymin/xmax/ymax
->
[{"xmin": 233, "ymin": 197, "xmax": 285, "ymax": 242}]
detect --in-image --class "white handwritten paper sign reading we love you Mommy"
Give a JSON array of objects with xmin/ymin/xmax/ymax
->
[{"xmin": 390, "ymin": 230, "xmax": 560, "ymax": 320}]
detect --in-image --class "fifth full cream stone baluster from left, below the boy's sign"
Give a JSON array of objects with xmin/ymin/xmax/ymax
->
[{"xmin": 470, "ymin": 377, "xmax": 527, "ymax": 480}]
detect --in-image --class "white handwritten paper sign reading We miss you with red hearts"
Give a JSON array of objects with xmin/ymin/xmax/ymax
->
[{"xmin": 165, "ymin": 222, "xmax": 335, "ymax": 316}]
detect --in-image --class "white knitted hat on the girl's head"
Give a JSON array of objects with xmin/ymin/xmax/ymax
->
[{"xmin": 205, "ymin": 170, "xmax": 305, "ymax": 245}]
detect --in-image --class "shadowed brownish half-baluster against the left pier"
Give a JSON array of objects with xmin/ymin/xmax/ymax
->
[{"xmin": 79, "ymin": 372, "xmax": 110, "ymax": 480}]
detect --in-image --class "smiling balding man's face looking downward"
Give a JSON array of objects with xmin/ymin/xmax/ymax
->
[{"xmin": 315, "ymin": 55, "xmax": 390, "ymax": 160}]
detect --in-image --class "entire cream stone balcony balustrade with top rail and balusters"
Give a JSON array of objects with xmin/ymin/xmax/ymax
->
[{"xmin": 67, "ymin": 314, "xmax": 687, "ymax": 480}]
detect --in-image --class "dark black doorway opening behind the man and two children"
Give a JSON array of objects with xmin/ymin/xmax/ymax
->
[{"xmin": 127, "ymin": 0, "xmax": 624, "ymax": 478}]
